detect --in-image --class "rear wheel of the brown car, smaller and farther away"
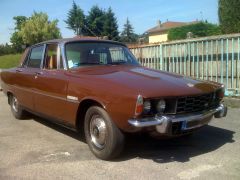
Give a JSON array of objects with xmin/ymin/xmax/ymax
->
[{"xmin": 8, "ymin": 95, "xmax": 26, "ymax": 119}]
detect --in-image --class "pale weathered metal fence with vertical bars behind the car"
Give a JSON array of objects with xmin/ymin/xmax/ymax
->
[{"xmin": 130, "ymin": 34, "xmax": 240, "ymax": 96}]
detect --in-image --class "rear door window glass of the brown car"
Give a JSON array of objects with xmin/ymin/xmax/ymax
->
[{"xmin": 27, "ymin": 45, "xmax": 44, "ymax": 68}]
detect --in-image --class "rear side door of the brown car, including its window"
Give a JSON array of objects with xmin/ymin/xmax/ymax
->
[{"xmin": 13, "ymin": 45, "xmax": 44, "ymax": 110}]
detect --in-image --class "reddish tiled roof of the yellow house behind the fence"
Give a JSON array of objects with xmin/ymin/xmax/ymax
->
[{"xmin": 146, "ymin": 21, "xmax": 199, "ymax": 33}]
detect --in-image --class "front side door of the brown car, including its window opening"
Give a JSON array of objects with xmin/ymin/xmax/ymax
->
[{"xmin": 34, "ymin": 43, "xmax": 69, "ymax": 123}]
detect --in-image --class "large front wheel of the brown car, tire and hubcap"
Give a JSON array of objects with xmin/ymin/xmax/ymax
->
[{"xmin": 84, "ymin": 106, "xmax": 125, "ymax": 160}]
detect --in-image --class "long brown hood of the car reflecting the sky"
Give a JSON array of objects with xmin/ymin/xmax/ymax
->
[{"xmin": 67, "ymin": 65, "xmax": 220, "ymax": 97}]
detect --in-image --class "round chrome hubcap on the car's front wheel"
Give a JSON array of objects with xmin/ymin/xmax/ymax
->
[{"xmin": 90, "ymin": 115, "xmax": 107, "ymax": 149}]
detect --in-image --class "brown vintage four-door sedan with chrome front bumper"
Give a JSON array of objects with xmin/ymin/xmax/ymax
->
[{"xmin": 1, "ymin": 38, "xmax": 227, "ymax": 159}]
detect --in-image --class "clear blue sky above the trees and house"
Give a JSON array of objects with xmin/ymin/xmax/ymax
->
[{"xmin": 0, "ymin": 0, "xmax": 218, "ymax": 44}]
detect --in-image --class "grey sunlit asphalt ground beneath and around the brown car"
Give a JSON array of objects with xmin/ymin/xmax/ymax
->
[{"xmin": 0, "ymin": 92, "xmax": 240, "ymax": 180}]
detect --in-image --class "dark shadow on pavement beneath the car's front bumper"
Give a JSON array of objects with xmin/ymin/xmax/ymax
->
[{"xmin": 117, "ymin": 125, "xmax": 235, "ymax": 163}]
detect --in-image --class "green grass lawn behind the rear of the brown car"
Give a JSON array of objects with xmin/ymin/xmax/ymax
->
[{"xmin": 0, "ymin": 54, "xmax": 21, "ymax": 69}]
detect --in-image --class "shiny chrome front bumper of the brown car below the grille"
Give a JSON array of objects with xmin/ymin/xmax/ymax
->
[{"xmin": 128, "ymin": 104, "xmax": 224, "ymax": 128}]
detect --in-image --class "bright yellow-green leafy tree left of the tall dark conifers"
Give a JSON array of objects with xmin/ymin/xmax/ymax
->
[{"xmin": 19, "ymin": 12, "xmax": 61, "ymax": 45}]
